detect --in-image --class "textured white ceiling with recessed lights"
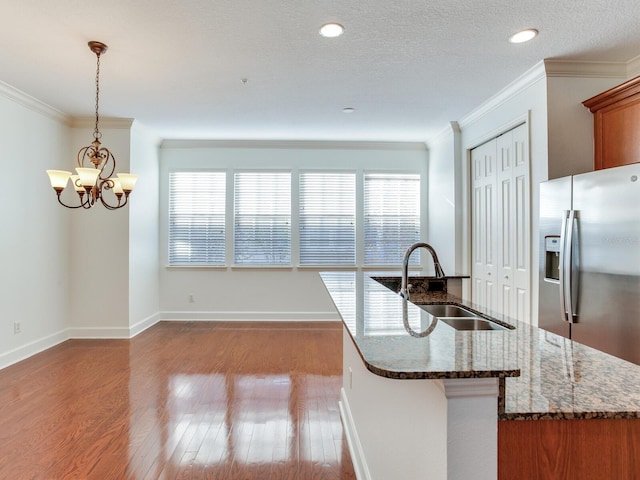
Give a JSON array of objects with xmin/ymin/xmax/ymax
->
[{"xmin": 0, "ymin": 0, "xmax": 640, "ymax": 141}]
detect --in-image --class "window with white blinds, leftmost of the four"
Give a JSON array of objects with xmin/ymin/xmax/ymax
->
[{"xmin": 169, "ymin": 172, "xmax": 226, "ymax": 265}]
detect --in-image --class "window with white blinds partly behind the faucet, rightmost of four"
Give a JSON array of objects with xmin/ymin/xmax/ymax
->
[{"xmin": 364, "ymin": 173, "xmax": 420, "ymax": 266}]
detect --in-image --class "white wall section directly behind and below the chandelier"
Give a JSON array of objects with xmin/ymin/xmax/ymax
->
[{"xmin": 69, "ymin": 119, "xmax": 135, "ymax": 338}]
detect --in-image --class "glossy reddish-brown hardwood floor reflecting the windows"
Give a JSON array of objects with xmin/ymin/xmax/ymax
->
[{"xmin": 0, "ymin": 322, "xmax": 355, "ymax": 480}]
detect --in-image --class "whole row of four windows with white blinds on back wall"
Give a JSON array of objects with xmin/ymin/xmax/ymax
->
[{"xmin": 168, "ymin": 168, "xmax": 420, "ymax": 268}]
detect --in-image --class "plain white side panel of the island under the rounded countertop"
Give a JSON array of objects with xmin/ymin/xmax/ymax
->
[{"xmin": 341, "ymin": 330, "xmax": 447, "ymax": 480}]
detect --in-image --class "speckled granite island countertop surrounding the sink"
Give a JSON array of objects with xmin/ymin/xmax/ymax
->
[{"xmin": 321, "ymin": 272, "xmax": 640, "ymax": 420}]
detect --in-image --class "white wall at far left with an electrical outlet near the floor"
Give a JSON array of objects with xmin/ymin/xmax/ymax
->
[{"xmin": 0, "ymin": 83, "xmax": 70, "ymax": 368}]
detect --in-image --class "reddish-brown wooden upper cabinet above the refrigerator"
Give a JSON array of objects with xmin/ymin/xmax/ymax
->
[{"xmin": 582, "ymin": 76, "xmax": 640, "ymax": 170}]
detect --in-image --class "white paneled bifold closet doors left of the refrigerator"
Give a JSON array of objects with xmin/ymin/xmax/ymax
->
[{"xmin": 471, "ymin": 125, "xmax": 531, "ymax": 322}]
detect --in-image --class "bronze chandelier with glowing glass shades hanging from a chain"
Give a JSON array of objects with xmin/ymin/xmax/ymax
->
[{"xmin": 47, "ymin": 42, "xmax": 138, "ymax": 210}]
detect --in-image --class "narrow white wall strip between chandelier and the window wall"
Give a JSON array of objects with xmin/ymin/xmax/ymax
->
[{"xmin": 125, "ymin": 122, "xmax": 160, "ymax": 335}]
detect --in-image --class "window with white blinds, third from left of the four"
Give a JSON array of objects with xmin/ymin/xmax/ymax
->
[{"xmin": 299, "ymin": 172, "xmax": 356, "ymax": 265}]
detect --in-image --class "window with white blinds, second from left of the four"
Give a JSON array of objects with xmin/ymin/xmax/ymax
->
[{"xmin": 234, "ymin": 172, "xmax": 291, "ymax": 265}]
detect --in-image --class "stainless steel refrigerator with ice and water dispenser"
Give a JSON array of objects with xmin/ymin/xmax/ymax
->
[{"xmin": 538, "ymin": 164, "xmax": 640, "ymax": 365}]
